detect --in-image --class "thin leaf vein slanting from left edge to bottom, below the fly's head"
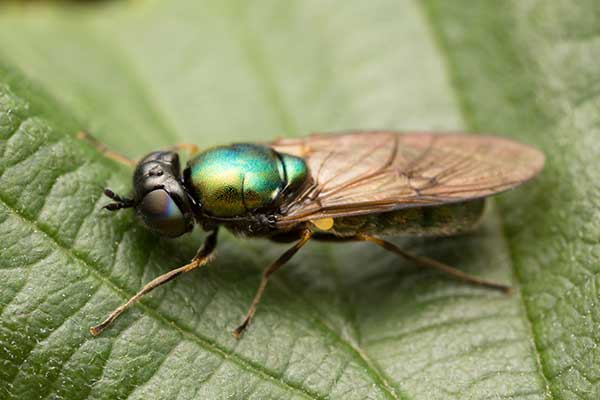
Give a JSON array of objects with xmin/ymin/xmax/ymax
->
[{"xmin": 0, "ymin": 194, "xmax": 323, "ymax": 399}]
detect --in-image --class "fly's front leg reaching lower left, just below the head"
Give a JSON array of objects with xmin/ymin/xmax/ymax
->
[{"xmin": 90, "ymin": 229, "xmax": 217, "ymax": 336}]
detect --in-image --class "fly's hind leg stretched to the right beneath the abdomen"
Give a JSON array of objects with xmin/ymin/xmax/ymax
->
[{"xmin": 355, "ymin": 235, "xmax": 511, "ymax": 293}]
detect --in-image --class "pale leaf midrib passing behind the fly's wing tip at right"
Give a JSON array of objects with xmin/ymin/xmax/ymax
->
[{"xmin": 417, "ymin": 1, "xmax": 555, "ymax": 399}]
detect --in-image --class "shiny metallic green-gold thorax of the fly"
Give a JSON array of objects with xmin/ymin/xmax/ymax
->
[{"xmin": 186, "ymin": 144, "xmax": 308, "ymax": 218}]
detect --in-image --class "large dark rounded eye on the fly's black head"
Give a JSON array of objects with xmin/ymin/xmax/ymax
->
[{"xmin": 138, "ymin": 189, "xmax": 188, "ymax": 237}]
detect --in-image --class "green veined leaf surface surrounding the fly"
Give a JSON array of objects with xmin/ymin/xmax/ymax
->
[{"xmin": 0, "ymin": 0, "xmax": 600, "ymax": 399}]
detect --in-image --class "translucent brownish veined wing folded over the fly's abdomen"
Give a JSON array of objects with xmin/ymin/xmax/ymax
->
[{"xmin": 269, "ymin": 131, "xmax": 544, "ymax": 227}]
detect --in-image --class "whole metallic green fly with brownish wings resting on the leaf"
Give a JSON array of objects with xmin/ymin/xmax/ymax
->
[{"xmin": 79, "ymin": 131, "xmax": 544, "ymax": 338}]
